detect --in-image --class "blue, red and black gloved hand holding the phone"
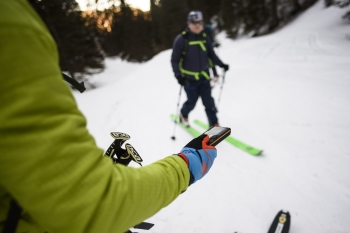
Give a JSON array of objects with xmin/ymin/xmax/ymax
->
[{"xmin": 177, "ymin": 134, "xmax": 216, "ymax": 185}]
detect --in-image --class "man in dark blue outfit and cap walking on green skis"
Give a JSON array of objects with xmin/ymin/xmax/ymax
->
[{"xmin": 171, "ymin": 11, "xmax": 229, "ymax": 127}]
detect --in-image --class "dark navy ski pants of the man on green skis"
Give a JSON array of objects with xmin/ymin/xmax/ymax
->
[{"xmin": 181, "ymin": 78, "xmax": 218, "ymax": 126}]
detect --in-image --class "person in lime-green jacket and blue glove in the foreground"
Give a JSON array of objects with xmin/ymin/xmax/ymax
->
[{"xmin": 0, "ymin": 0, "xmax": 216, "ymax": 233}]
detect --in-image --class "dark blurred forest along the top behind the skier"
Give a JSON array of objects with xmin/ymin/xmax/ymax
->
[{"xmin": 28, "ymin": 0, "xmax": 350, "ymax": 79}]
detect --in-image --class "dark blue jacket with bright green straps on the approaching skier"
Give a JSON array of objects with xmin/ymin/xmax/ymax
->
[{"xmin": 171, "ymin": 28, "xmax": 224, "ymax": 80}]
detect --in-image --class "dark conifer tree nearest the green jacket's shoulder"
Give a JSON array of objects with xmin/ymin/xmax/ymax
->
[{"xmin": 29, "ymin": 0, "xmax": 104, "ymax": 78}]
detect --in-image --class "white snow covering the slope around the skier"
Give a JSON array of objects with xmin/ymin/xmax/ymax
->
[{"xmin": 74, "ymin": 1, "xmax": 350, "ymax": 233}]
